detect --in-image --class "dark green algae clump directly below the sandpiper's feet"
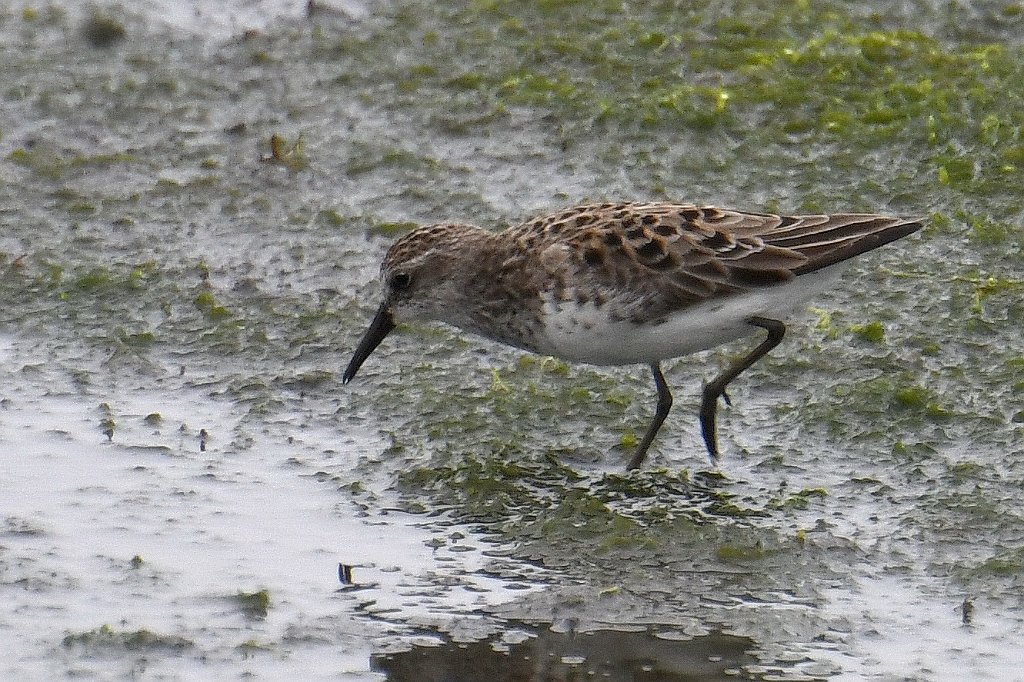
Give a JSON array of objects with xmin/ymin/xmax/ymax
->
[{"xmin": 396, "ymin": 452, "xmax": 765, "ymax": 551}]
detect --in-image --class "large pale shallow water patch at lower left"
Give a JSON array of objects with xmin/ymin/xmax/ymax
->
[{"xmin": 0, "ymin": 329, "xmax": 552, "ymax": 679}]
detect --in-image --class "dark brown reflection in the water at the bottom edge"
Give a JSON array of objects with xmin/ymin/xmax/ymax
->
[{"xmin": 370, "ymin": 624, "xmax": 757, "ymax": 682}]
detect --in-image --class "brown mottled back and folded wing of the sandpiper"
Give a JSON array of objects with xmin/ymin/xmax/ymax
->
[{"xmin": 499, "ymin": 203, "xmax": 921, "ymax": 314}]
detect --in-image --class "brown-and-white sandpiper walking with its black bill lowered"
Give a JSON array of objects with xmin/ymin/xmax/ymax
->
[{"xmin": 342, "ymin": 202, "xmax": 922, "ymax": 469}]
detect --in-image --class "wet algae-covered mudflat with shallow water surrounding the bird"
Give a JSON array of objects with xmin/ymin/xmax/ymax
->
[{"xmin": 0, "ymin": 0, "xmax": 1024, "ymax": 680}]
